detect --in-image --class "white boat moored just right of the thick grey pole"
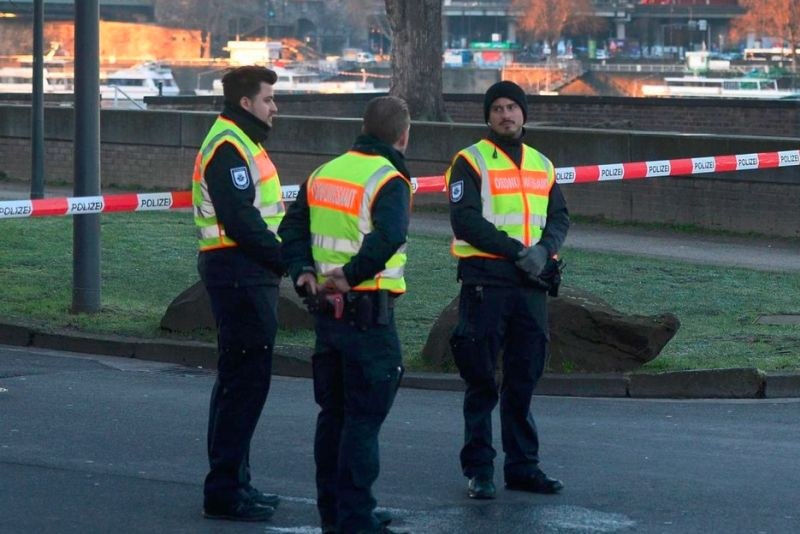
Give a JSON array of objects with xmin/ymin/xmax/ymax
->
[{"xmin": 100, "ymin": 61, "xmax": 180, "ymax": 100}]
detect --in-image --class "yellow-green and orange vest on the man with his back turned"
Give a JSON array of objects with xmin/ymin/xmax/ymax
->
[{"xmin": 306, "ymin": 151, "xmax": 411, "ymax": 293}]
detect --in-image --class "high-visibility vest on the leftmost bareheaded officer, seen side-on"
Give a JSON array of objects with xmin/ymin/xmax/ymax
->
[{"xmin": 192, "ymin": 116, "xmax": 285, "ymax": 250}]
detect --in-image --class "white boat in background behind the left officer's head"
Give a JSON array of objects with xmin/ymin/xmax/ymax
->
[{"xmin": 195, "ymin": 66, "xmax": 386, "ymax": 95}]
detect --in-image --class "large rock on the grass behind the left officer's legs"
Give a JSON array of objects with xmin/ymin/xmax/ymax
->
[{"xmin": 161, "ymin": 278, "xmax": 314, "ymax": 332}]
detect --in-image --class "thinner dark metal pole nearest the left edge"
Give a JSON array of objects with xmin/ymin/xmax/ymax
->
[{"xmin": 31, "ymin": 0, "xmax": 44, "ymax": 198}]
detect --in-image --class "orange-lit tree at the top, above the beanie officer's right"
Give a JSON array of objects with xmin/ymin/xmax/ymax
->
[{"xmin": 512, "ymin": 0, "xmax": 596, "ymax": 56}]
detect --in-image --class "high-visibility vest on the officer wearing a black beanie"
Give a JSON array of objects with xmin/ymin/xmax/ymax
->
[{"xmin": 445, "ymin": 139, "xmax": 555, "ymax": 258}]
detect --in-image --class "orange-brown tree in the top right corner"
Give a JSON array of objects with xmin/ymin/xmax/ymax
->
[{"xmin": 731, "ymin": 0, "xmax": 800, "ymax": 70}]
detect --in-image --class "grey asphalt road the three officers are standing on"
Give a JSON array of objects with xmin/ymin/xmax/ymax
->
[{"xmin": 0, "ymin": 346, "xmax": 800, "ymax": 534}]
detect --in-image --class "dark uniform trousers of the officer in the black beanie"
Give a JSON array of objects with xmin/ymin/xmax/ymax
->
[{"xmin": 450, "ymin": 285, "xmax": 549, "ymax": 481}]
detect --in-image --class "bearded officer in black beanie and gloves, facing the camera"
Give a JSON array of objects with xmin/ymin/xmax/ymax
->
[{"xmin": 445, "ymin": 81, "xmax": 569, "ymax": 499}]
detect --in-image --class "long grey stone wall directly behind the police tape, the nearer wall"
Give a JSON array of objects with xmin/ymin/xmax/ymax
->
[{"xmin": 0, "ymin": 105, "xmax": 800, "ymax": 237}]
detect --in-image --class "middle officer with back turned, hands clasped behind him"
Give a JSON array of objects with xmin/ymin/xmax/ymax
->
[{"xmin": 278, "ymin": 96, "xmax": 411, "ymax": 534}]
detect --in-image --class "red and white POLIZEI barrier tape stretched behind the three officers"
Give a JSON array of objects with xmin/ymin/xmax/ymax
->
[{"xmin": 0, "ymin": 150, "xmax": 800, "ymax": 219}]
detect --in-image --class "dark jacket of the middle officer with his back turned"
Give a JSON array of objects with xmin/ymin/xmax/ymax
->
[{"xmin": 278, "ymin": 135, "xmax": 411, "ymax": 294}]
